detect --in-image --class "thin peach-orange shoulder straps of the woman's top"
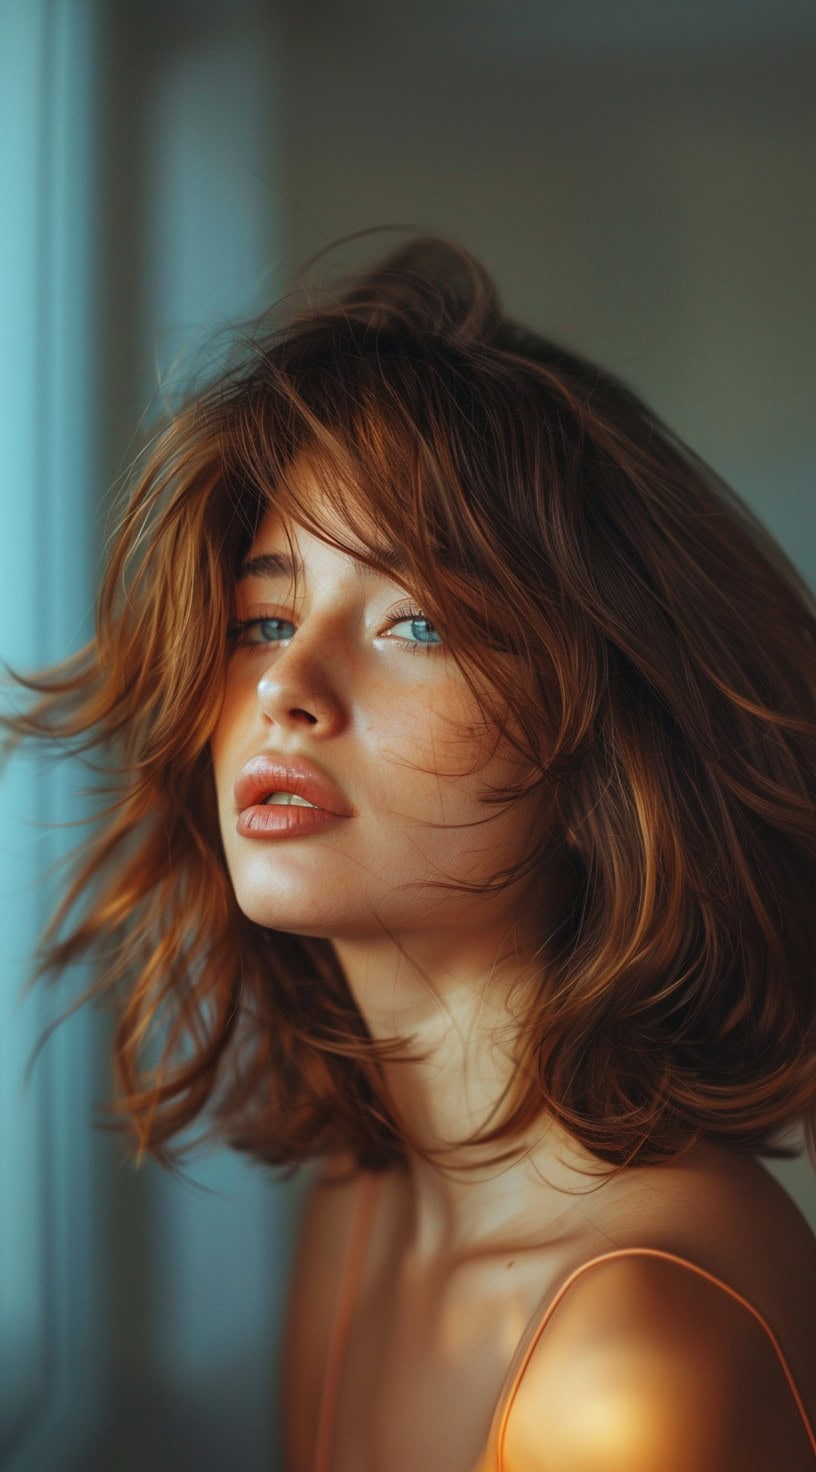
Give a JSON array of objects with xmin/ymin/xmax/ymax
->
[{"xmin": 312, "ymin": 1172, "xmax": 816, "ymax": 1472}]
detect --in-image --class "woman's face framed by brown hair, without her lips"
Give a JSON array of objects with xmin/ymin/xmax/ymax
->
[{"xmin": 211, "ymin": 468, "xmax": 536, "ymax": 939}]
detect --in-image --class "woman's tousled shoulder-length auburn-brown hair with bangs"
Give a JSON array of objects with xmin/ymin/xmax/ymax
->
[{"xmin": 6, "ymin": 238, "xmax": 816, "ymax": 1169}]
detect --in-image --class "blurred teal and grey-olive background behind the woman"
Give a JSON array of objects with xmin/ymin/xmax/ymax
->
[{"xmin": 0, "ymin": 0, "xmax": 816, "ymax": 1472}]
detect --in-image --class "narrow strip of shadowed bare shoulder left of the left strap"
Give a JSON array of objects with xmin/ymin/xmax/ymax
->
[{"xmin": 281, "ymin": 1156, "xmax": 362, "ymax": 1472}]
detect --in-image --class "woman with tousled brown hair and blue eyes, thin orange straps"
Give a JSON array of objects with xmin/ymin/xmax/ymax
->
[{"xmin": 7, "ymin": 238, "xmax": 816, "ymax": 1472}]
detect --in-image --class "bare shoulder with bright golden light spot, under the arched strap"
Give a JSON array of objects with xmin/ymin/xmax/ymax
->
[{"xmin": 504, "ymin": 1250, "xmax": 816, "ymax": 1472}]
